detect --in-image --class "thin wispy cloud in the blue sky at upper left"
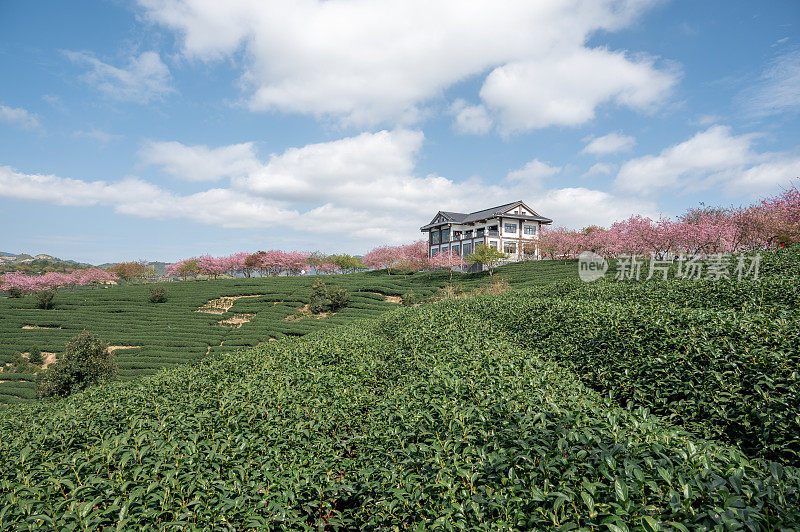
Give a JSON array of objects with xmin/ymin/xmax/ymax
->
[{"xmin": 64, "ymin": 51, "xmax": 175, "ymax": 104}]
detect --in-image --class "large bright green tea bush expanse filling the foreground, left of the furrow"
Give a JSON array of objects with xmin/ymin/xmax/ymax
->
[{"xmin": 0, "ymin": 304, "xmax": 800, "ymax": 531}]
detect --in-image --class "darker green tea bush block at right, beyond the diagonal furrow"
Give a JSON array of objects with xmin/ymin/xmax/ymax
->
[{"xmin": 460, "ymin": 292, "xmax": 800, "ymax": 464}]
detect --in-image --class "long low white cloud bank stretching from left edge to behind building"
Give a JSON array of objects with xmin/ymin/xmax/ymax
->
[{"xmin": 0, "ymin": 129, "xmax": 647, "ymax": 243}]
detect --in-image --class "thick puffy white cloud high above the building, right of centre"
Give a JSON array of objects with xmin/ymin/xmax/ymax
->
[{"xmin": 480, "ymin": 48, "xmax": 676, "ymax": 132}]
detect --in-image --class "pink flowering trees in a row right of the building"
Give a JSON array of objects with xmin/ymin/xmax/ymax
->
[{"xmin": 539, "ymin": 187, "xmax": 800, "ymax": 259}]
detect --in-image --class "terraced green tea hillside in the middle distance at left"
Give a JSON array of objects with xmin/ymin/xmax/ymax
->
[{"xmin": 0, "ymin": 261, "xmax": 577, "ymax": 403}]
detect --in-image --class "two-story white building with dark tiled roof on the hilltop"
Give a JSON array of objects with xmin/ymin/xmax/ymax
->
[{"xmin": 420, "ymin": 201, "xmax": 553, "ymax": 261}]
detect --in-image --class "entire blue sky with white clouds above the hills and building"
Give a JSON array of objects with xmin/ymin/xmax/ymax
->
[{"xmin": 0, "ymin": 0, "xmax": 800, "ymax": 263}]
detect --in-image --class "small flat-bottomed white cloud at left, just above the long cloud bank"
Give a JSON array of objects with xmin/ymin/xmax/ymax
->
[{"xmin": 139, "ymin": 142, "xmax": 259, "ymax": 181}]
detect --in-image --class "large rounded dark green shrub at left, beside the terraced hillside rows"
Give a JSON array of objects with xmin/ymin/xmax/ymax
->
[{"xmin": 37, "ymin": 331, "xmax": 118, "ymax": 397}]
